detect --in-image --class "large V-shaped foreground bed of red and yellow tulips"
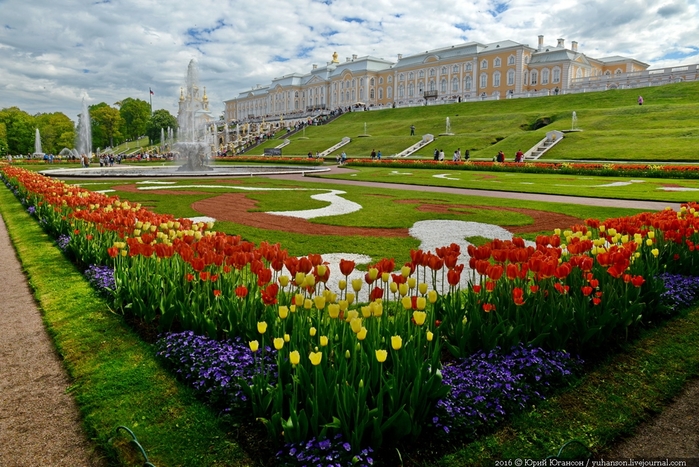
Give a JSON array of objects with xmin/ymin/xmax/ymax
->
[{"xmin": 3, "ymin": 168, "xmax": 699, "ymax": 455}]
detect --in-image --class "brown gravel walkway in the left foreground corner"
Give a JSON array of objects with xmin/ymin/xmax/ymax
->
[{"xmin": 0, "ymin": 215, "xmax": 105, "ymax": 467}]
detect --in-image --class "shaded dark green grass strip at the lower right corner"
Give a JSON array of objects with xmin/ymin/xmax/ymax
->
[{"xmin": 439, "ymin": 309, "xmax": 699, "ymax": 467}]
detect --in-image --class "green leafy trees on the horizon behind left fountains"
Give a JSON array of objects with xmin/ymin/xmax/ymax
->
[{"xmin": 0, "ymin": 97, "xmax": 177, "ymax": 155}]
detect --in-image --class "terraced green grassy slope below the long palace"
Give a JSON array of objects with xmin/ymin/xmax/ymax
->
[{"xmin": 251, "ymin": 82, "xmax": 699, "ymax": 161}]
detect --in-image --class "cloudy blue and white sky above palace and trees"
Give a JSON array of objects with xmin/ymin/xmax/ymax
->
[{"xmin": 0, "ymin": 0, "xmax": 699, "ymax": 122}]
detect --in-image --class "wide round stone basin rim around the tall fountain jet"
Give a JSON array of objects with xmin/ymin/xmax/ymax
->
[{"xmin": 39, "ymin": 165, "xmax": 330, "ymax": 178}]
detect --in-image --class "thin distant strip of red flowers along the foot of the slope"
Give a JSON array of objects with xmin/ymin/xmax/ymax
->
[{"xmin": 345, "ymin": 159, "xmax": 699, "ymax": 179}]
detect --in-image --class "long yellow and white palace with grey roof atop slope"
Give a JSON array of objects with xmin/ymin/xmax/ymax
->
[{"xmin": 225, "ymin": 36, "xmax": 648, "ymax": 121}]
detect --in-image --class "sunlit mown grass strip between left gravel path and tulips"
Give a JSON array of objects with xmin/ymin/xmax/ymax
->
[{"xmin": 0, "ymin": 188, "xmax": 252, "ymax": 467}]
